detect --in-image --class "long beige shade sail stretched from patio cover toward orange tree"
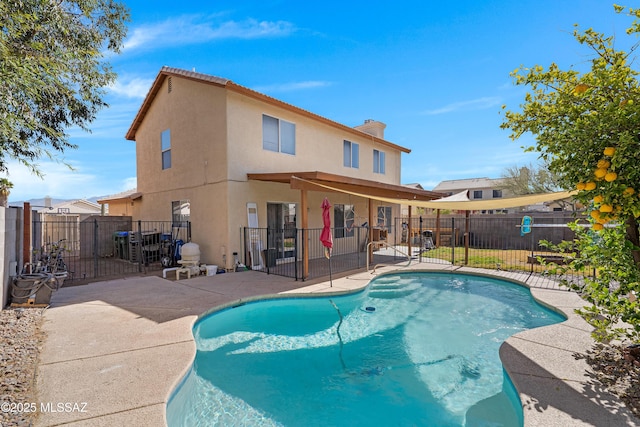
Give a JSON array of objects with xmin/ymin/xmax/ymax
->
[{"xmin": 291, "ymin": 176, "xmax": 576, "ymax": 211}]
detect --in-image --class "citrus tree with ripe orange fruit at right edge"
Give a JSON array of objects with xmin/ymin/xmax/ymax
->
[{"xmin": 501, "ymin": 6, "xmax": 640, "ymax": 341}]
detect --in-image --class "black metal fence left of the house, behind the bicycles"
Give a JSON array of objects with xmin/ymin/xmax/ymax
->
[{"xmin": 30, "ymin": 216, "xmax": 190, "ymax": 283}]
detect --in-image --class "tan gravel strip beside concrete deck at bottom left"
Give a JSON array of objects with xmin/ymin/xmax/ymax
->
[{"xmin": 0, "ymin": 308, "xmax": 44, "ymax": 427}]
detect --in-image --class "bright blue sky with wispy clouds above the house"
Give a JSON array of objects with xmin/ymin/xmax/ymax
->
[{"xmin": 9, "ymin": 0, "xmax": 631, "ymax": 201}]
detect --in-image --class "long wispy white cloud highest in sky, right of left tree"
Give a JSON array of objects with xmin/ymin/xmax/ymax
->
[{"xmin": 123, "ymin": 15, "xmax": 296, "ymax": 52}]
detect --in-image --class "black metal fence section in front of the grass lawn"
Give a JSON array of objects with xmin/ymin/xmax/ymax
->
[{"xmin": 394, "ymin": 213, "xmax": 586, "ymax": 277}]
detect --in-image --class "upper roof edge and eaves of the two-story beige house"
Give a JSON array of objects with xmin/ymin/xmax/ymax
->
[{"xmin": 125, "ymin": 66, "xmax": 411, "ymax": 153}]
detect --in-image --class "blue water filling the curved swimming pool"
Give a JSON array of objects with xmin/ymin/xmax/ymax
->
[{"xmin": 167, "ymin": 273, "xmax": 564, "ymax": 427}]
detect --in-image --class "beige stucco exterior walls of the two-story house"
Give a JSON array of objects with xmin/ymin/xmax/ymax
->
[{"xmin": 131, "ymin": 76, "xmax": 401, "ymax": 268}]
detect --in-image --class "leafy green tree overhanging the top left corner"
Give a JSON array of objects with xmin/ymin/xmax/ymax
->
[{"xmin": 0, "ymin": 0, "xmax": 129, "ymax": 175}]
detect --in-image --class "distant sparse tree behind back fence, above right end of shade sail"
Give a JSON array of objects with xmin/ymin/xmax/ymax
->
[{"xmin": 498, "ymin": 164, "xmax": 575, "ymax": 210}]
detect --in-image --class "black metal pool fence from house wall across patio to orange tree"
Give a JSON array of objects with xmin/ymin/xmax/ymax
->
[{"xmin": 243, "ymin": 213, "xmax": 582, "ymax": 280}]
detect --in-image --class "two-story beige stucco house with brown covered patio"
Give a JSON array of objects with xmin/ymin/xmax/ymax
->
[{"xmin": 122, "ymin": 67, "xmax": 440, "ymax": 274}]
